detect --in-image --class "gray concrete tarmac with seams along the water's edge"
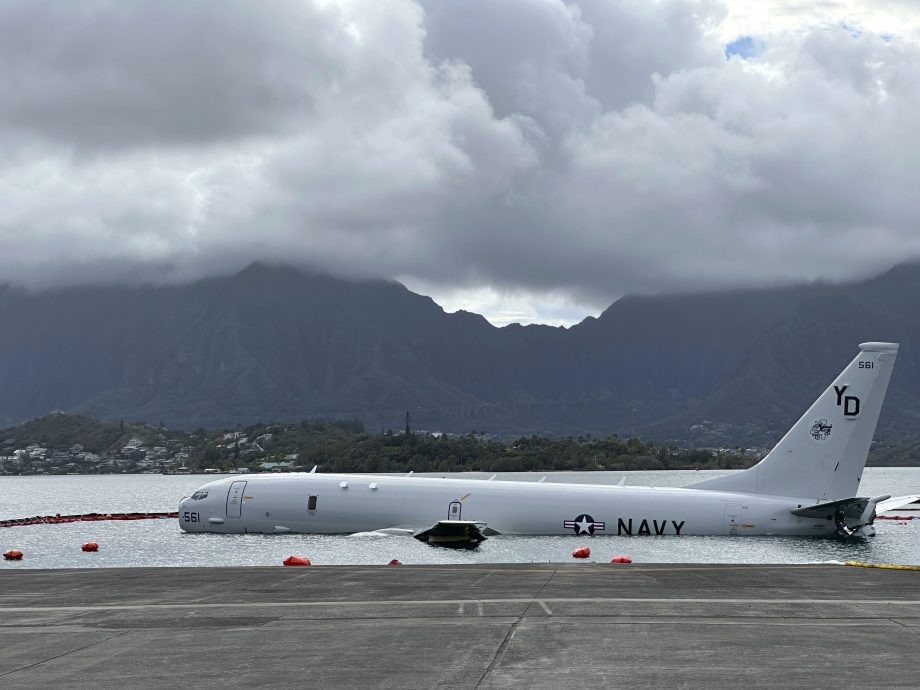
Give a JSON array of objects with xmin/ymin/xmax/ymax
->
[{"xmin": 0, "ymin": 563, "xmax": 920, "ymax": 690}]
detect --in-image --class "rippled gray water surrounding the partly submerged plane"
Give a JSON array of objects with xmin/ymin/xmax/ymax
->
[{"xmin": 0, "ymin": 467, "xmax": 920, "ymax": 569}]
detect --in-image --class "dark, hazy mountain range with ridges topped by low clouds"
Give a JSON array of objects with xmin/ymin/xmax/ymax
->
[{"xmin": 0, "ymin": 264, "xmax": 920, "ymax": 445}]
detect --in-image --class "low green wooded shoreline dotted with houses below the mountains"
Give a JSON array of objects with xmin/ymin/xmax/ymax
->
[{"xmin": 0, "ymin": 413, "xmax": 920, "ymax": 473}]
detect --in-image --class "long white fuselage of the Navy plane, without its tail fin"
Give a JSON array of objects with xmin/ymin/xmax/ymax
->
[{"xmin": 179, "ymin": 473, "xmax": 835, "ymax": 536}]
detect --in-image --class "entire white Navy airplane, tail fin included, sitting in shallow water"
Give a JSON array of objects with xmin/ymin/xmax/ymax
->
[{"xmin": 179, "ymin": 343, "xmax": 916, "ymax": 546}]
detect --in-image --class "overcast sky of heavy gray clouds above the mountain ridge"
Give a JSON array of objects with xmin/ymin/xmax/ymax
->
[{"xmin": 0, "ymin": 0, "xmax": 920, "ymax": 325}]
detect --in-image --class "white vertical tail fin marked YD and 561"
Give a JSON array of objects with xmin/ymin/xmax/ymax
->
[{"xmin": 692, "ymin": 343, "xmax": 898, "ymax": 501}]
